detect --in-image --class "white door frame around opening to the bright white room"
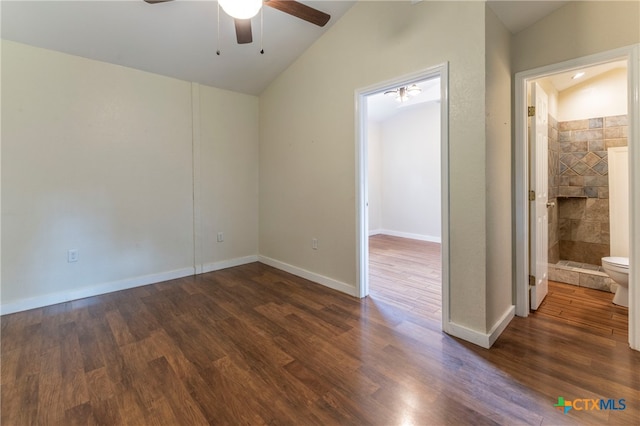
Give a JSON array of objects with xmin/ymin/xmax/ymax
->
[{"xmin": 355, "ymin": 62, "xmax": 449, "ymax": 331}]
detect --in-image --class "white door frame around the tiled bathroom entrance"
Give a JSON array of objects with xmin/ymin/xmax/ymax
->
[{"xmin": 514, "ymin": 44, "xmax": 640, "ymax": 350}]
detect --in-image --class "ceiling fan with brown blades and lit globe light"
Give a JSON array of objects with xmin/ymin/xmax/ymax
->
[{"xmin": 144, "ymin": 0, "xmax": 331, "ymax": 44}]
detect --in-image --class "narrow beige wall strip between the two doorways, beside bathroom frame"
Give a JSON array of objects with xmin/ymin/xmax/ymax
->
[{"xmin": 485, "ymin": 7, "xmax": 513, "ymax": 330}]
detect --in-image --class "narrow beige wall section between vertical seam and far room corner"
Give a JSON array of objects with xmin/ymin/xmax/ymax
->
[{"xmin": 199, "ymin": 86, "xmax": 258, "ymax": 270}]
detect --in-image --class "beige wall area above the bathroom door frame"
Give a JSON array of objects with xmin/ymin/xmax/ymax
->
[{"xmin": 511, "ymin": 1, "xmax": 640, "ymax": 73}]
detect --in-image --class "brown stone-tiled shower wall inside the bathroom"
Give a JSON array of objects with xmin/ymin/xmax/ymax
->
[{"xmin": 549, "ymin": 115, "xmax": 628, "ymax": 265}]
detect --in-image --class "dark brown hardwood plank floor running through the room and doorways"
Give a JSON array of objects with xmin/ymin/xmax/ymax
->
[{"xmin": 0, "ymin": 235, "xmax": 640, "ymax": 425}]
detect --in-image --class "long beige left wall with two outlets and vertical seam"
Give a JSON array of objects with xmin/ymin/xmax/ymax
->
[{"xmin": 1, "ymin": 40, "xmax": 258, "ymax": 312}]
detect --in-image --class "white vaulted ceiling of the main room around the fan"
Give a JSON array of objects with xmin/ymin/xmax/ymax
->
[{"xmin": 1, "ymin": 0, "xmax": 567, "ymax": 95}]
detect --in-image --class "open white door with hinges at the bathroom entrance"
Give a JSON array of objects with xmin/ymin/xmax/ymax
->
[{"xmin": 529, "ymin": 83, "xmax": 549, "ymax": 310}]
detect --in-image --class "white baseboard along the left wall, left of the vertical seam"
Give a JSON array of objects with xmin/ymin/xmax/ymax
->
[{"xmin": 0, "ymin": 267, "xmax": 194, "ymax": 315}]
